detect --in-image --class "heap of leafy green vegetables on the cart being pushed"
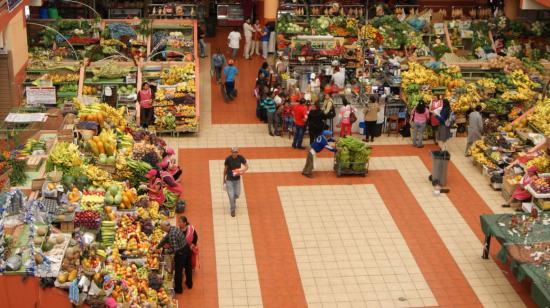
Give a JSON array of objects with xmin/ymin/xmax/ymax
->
[{"xmin": 336, "ymin": 136, "xmax": 372, "ymax": 171}]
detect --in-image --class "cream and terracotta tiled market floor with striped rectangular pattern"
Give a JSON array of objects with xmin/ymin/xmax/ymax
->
[{"xmin": 167, "ymin": 38, "xmax": 535, "ymax": 308}]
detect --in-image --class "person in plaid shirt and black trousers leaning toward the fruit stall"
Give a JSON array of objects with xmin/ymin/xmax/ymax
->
[{"xmin": 156, "ymin": 220, "xmax": 193, "ymax": 294}]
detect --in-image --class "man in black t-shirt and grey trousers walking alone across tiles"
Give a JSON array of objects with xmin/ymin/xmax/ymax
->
[{"xmin": 223, "ymin": 148, "xmax": 248, "ymax": 217}]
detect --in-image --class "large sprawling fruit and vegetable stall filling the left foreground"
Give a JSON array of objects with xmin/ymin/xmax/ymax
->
[{"xmin": 0, "ymin": 115, "xmax": 179, "ymax": 307}]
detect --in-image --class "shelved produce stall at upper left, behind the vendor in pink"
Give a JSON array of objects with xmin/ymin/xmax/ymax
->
[{"xmin": 26, "ymin": 20, "xmax": 199, "ymax": 134}]
